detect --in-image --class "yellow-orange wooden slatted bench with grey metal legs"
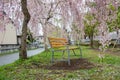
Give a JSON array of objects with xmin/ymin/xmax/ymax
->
[{"xmin": 48, "ymin": 37, "xmax": 82, "ymax": 65}]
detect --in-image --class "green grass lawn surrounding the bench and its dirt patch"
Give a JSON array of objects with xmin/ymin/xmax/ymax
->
[{"xmin": 0, "ymin": 46, "xmax": 120, "ymax": 80}]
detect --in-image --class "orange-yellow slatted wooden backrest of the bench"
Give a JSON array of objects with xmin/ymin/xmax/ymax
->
[{"xmin": 48, "ymin": 37, "xmax": 68, "ymax": 48}]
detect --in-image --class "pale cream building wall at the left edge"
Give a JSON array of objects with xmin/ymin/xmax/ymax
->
[{"xmin": 0, "ymin": 23, "xmax": 17, "ymax": 44}]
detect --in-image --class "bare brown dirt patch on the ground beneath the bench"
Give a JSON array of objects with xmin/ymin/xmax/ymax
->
[{"xmin": 46, "ymin": 58, "xmax": 95, "ymax": 70}]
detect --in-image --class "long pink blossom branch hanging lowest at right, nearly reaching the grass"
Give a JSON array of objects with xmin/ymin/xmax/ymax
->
[{"xmin": 86, "ymin": 0, "xmax": 117, "ymax": 61}]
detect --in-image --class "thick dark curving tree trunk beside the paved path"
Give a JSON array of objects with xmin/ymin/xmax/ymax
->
[{"xmin": 19, "ymin": 0, "xmax": 30, "ymax": 59}]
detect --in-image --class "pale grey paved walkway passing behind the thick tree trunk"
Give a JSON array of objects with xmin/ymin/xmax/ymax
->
[{"xmin": 0, "ymin": 48, "xmax": 44, "ymax": 66}]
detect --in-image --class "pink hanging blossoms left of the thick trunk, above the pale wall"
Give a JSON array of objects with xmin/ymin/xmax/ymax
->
[{"xmin": 2, "ymin": 0, "xmax": 23, "ymax": 33}]
